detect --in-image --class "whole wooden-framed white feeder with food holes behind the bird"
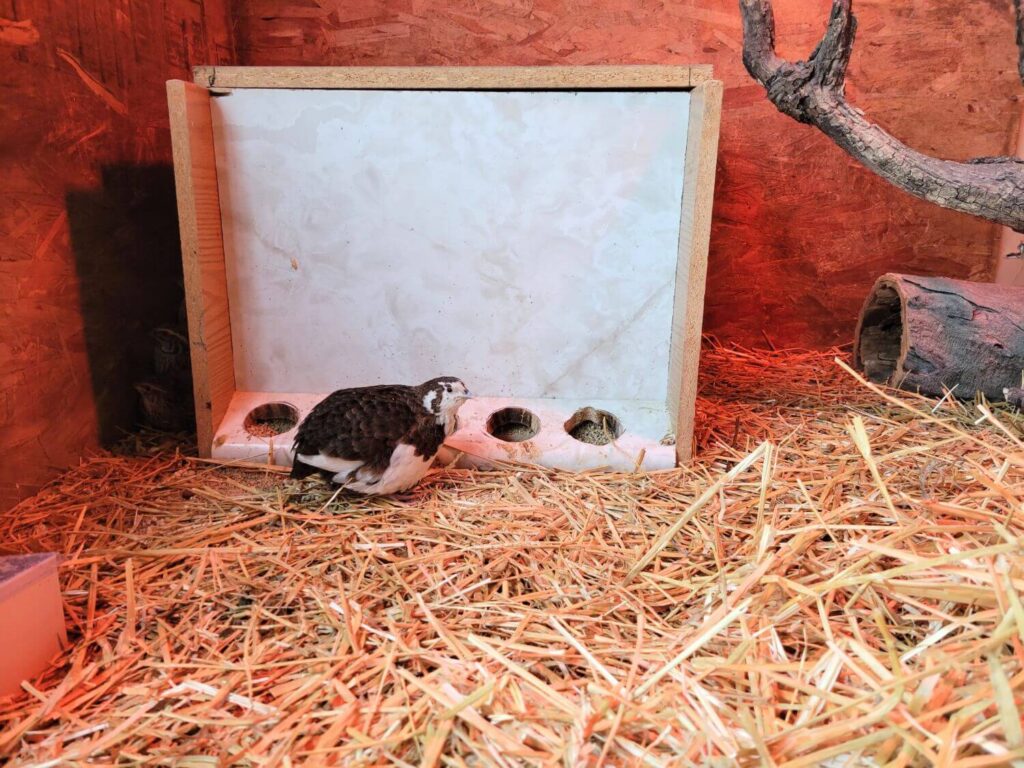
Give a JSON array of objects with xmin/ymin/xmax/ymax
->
[{"xmin": 168, "ymin": 67, "xmax": 722, "ymax": 470}]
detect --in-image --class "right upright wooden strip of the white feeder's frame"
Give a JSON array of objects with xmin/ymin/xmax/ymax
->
[{"xmin": 668, "ymin": 80, "xmax": 723, "ymax": 463}]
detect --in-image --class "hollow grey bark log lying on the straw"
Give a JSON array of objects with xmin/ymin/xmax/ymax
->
[{"xmin": 853, "ymin": 273, "xmax": 1024, "ymax": 400}]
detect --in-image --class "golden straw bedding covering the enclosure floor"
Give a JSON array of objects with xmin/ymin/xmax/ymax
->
[{"xmin": 0, "ymin": 346, "xmax": 1024, "ymax": 768}]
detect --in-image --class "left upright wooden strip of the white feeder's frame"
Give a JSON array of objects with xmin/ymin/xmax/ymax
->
[{"xmin": 167, "ymin": 80, "xmax": 234, "ymax": 457}]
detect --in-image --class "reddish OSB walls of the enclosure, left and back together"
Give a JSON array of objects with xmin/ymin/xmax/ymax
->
[{"xmin": 0, "ymin": 0, "xmax": 1022, "ymax": 509}]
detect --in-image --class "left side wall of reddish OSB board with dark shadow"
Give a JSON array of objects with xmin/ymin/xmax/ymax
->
[{"xmin": 0, "ymin": 0, "xmax": 232, "ymax": 514}]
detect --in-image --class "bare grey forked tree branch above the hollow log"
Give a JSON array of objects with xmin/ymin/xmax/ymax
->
[{"xmin": 739, "ymin": 0, "xmax": 1024, "ymax": 232}]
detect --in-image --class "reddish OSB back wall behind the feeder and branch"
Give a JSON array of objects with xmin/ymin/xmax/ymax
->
[{"xmin": 233, "ymin": 0, "xmax": 1024, "ymax": 346}]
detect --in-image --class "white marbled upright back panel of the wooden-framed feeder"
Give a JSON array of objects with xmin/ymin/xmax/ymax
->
[{"xmin": 213, "ymin": 89, "xmax": 689, "ymax": 402}]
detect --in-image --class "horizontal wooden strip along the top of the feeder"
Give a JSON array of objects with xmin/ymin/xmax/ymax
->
[{"xmin": 193, "ymin": 65, "xmax": 712, "ymax": 90}]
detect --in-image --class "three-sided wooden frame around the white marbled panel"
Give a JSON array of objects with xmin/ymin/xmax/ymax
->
[{"xmin": 167, "ymin": 66, "xmax": 722, "ymax": 462}]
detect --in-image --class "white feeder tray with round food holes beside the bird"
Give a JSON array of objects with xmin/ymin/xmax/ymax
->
[{"xmin": 214, "ymin": 393, "xmax": 676, "ymax": 471}]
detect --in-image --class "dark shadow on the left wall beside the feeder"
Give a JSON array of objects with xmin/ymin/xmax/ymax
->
[{"xmin": 67, "ymin": 165, "xmax": 194, "ymax": 446}]
